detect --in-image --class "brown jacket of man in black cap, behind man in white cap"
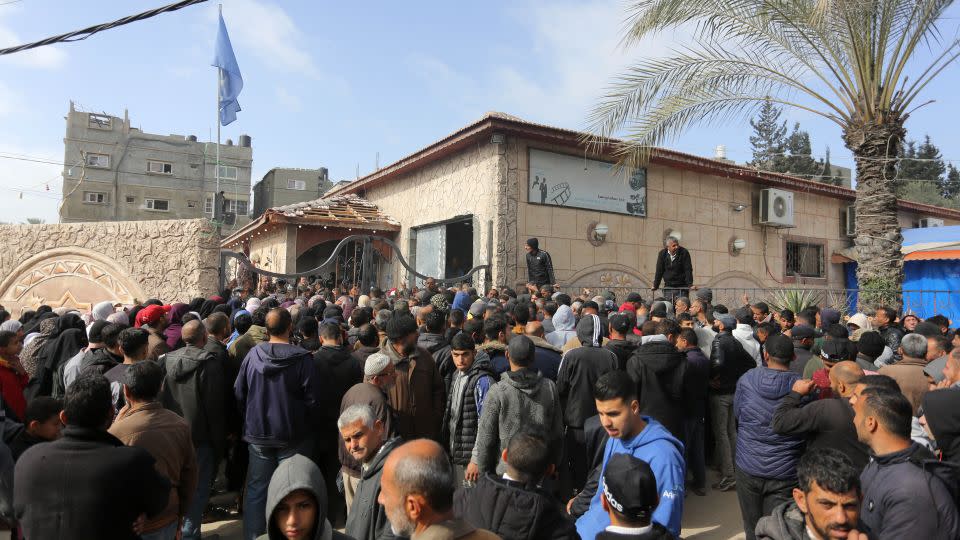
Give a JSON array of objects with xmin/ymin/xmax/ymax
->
[{"xmin": 381, "ymin": 339, "xmax": 447, "ymax": 441}]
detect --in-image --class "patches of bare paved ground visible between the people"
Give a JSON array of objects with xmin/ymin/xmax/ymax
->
[{"xmin": 203, "ymin": 471, "xmax": 744, "ymax": 540}]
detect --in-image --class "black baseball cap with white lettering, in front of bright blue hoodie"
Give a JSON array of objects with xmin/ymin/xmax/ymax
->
[{"xmin": 603, "ymin": 454, "xmax": 658, "ymax": 521}]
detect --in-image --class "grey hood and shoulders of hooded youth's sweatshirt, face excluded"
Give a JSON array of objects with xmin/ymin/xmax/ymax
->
[{"xmin": 257, "ymin": 454, "xmax": 349, "ymax": 540}]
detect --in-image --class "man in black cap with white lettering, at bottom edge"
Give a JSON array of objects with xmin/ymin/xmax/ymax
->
[{"xmin": 597, "ymin": 454, "xmax": 673, "ymax": 540}]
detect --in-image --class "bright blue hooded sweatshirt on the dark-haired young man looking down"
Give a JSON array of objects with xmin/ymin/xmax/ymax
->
[{"xmin": 577, "ymin": 416, "xmax": 685, "ymax": 538}]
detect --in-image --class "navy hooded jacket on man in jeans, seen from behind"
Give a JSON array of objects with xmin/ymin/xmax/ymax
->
[{"xmin": 233, "ymin": 343, "xmax": 321, "ymax": 447}]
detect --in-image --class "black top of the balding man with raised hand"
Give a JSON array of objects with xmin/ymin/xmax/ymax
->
[{"xmin": 770, "ymin": 392, "xmax": 870, "ymax": 471}]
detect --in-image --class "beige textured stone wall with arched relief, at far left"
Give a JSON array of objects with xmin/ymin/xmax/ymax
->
[{"xmin": 0, "ymin": 219, "xmax": 219, "ymax": 315}]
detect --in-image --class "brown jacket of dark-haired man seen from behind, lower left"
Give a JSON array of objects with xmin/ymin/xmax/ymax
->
[{"xmin": 110, "ymin": 401, "xmax": 197, "ymax": 532}]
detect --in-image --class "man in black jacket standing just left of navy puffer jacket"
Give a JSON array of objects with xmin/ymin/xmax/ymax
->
[{"xmin": 707, "ymin": 313, "xmax": 757, "ymax": 491}]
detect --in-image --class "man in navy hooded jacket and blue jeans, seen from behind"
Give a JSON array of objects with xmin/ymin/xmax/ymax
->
[{"xmin": 233, "ymin": 308, "xmax": 322, "ymax": 540}]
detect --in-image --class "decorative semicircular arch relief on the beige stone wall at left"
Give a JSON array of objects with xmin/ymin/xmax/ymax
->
[{"xmin": 0, "ymin": 246, "xmax": 146, "ymax": 310}]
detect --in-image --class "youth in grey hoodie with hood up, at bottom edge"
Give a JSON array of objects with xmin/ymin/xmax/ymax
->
[{"xmin": 257, "ymin": 454, "xmax": 350, "ymax": 540}]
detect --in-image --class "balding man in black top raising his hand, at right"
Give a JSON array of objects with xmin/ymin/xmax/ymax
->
[{"xmin": 770, "ymin": 361, "xmax": 870, "ymax": 471}]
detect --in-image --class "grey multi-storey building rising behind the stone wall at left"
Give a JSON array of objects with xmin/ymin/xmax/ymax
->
[{"xmin": 60, "ymin": 102, "xmax": 253, "ymax": 229}]
